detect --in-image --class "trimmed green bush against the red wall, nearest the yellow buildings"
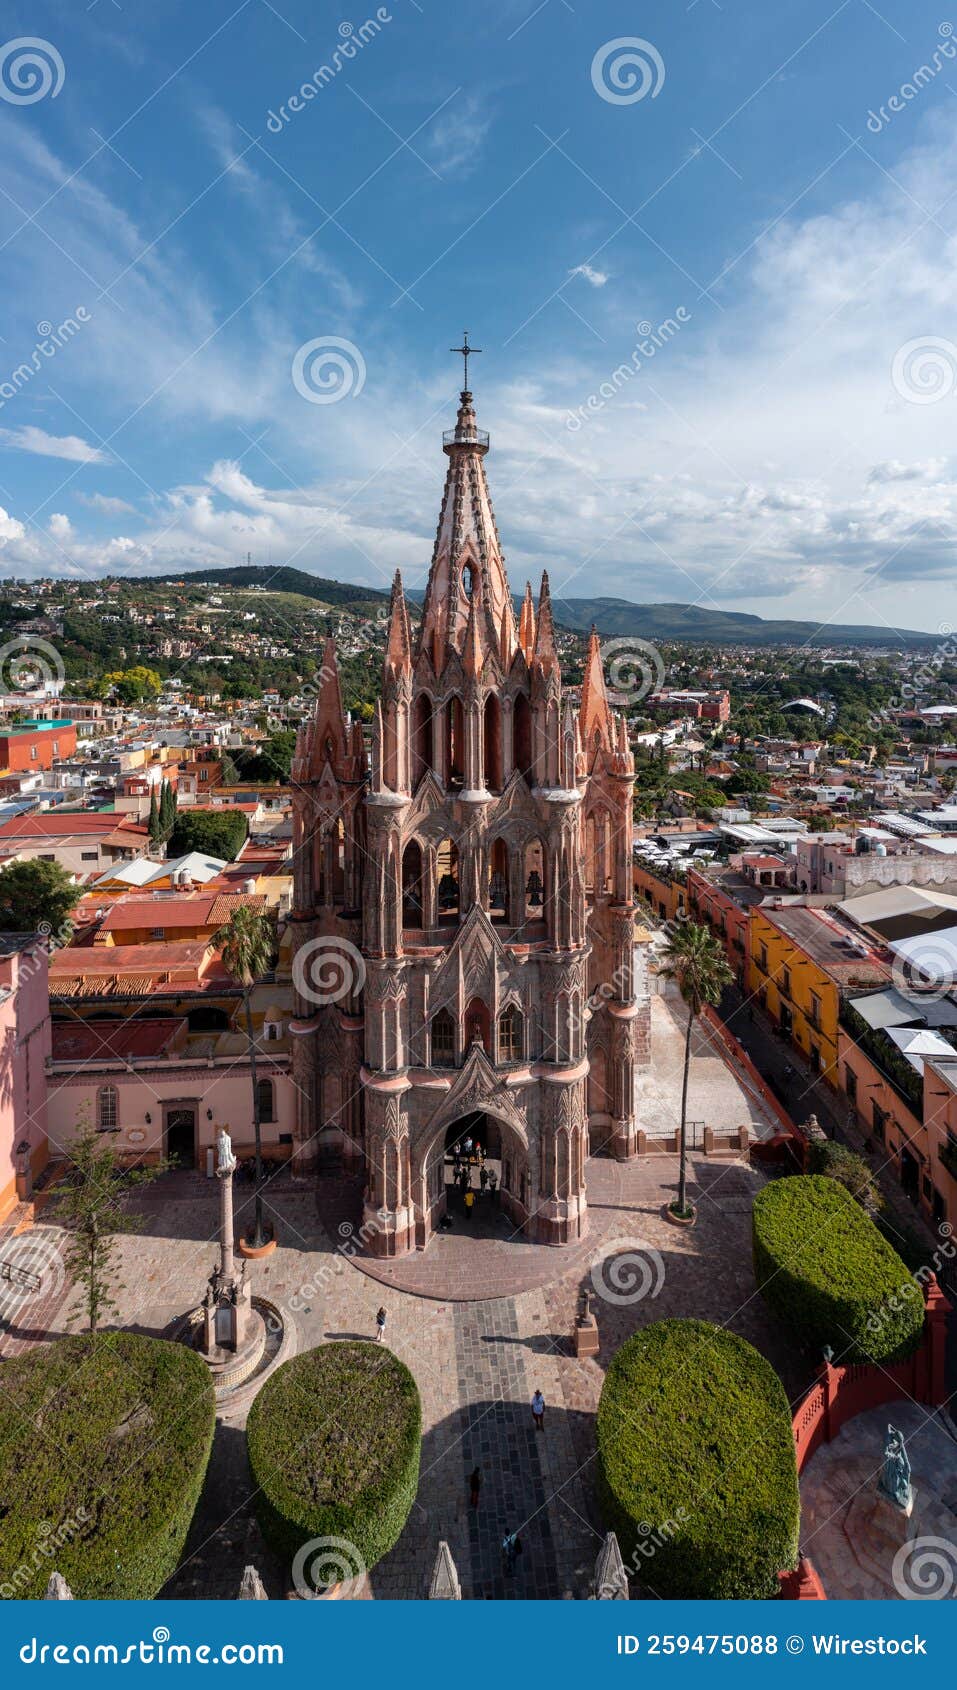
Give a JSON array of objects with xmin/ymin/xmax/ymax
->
[{"xmin": 752, "ymin": 1175, "xmax": 923, "ymax": 1364}]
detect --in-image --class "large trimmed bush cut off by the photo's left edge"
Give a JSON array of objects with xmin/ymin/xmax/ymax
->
[{"xmin": 0, "ymin": 1332, "xmax": 216, "ymax": 1600}]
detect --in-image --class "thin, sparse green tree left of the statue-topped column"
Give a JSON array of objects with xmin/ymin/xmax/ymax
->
[{"xmin": 51, "ymin": 1122, "xmax": 166, "ymax": 1332}]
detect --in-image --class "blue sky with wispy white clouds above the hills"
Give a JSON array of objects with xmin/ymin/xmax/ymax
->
[{"xmin": 0, "ymin": 0, "xmax": 957, "ymax": 629}]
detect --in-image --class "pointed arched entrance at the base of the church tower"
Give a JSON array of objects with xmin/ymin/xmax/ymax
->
[{"xmin": 421, "ymin": 1109, "xmax": 529, "ymax": 1242}]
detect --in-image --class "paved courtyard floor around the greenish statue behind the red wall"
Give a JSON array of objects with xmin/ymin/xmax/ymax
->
[{"xmin": 801, "ymin": 1403, "xmax": 957, "ymax": 1600}]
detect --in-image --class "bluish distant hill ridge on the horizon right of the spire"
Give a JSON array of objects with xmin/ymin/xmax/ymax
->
[{"xmin": 553, "ymin": 593, "xmax": 935, "ymax": 647}]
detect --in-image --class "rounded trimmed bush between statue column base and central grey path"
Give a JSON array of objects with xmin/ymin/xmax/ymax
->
[{"xmin": 247, "ymin": 1340, "xmax": 423, "ymax": 1570}]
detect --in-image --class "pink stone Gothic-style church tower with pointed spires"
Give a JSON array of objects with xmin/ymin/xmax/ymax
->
[{"xmin": 293, "ymin": 392, "xmax": 648, "ymax": 1254}]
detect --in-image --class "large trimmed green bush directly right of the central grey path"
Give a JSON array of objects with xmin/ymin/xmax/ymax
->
[{"xmin": 597, "ymin": 1320, "xmax": 800, "ymax": 1599}]
